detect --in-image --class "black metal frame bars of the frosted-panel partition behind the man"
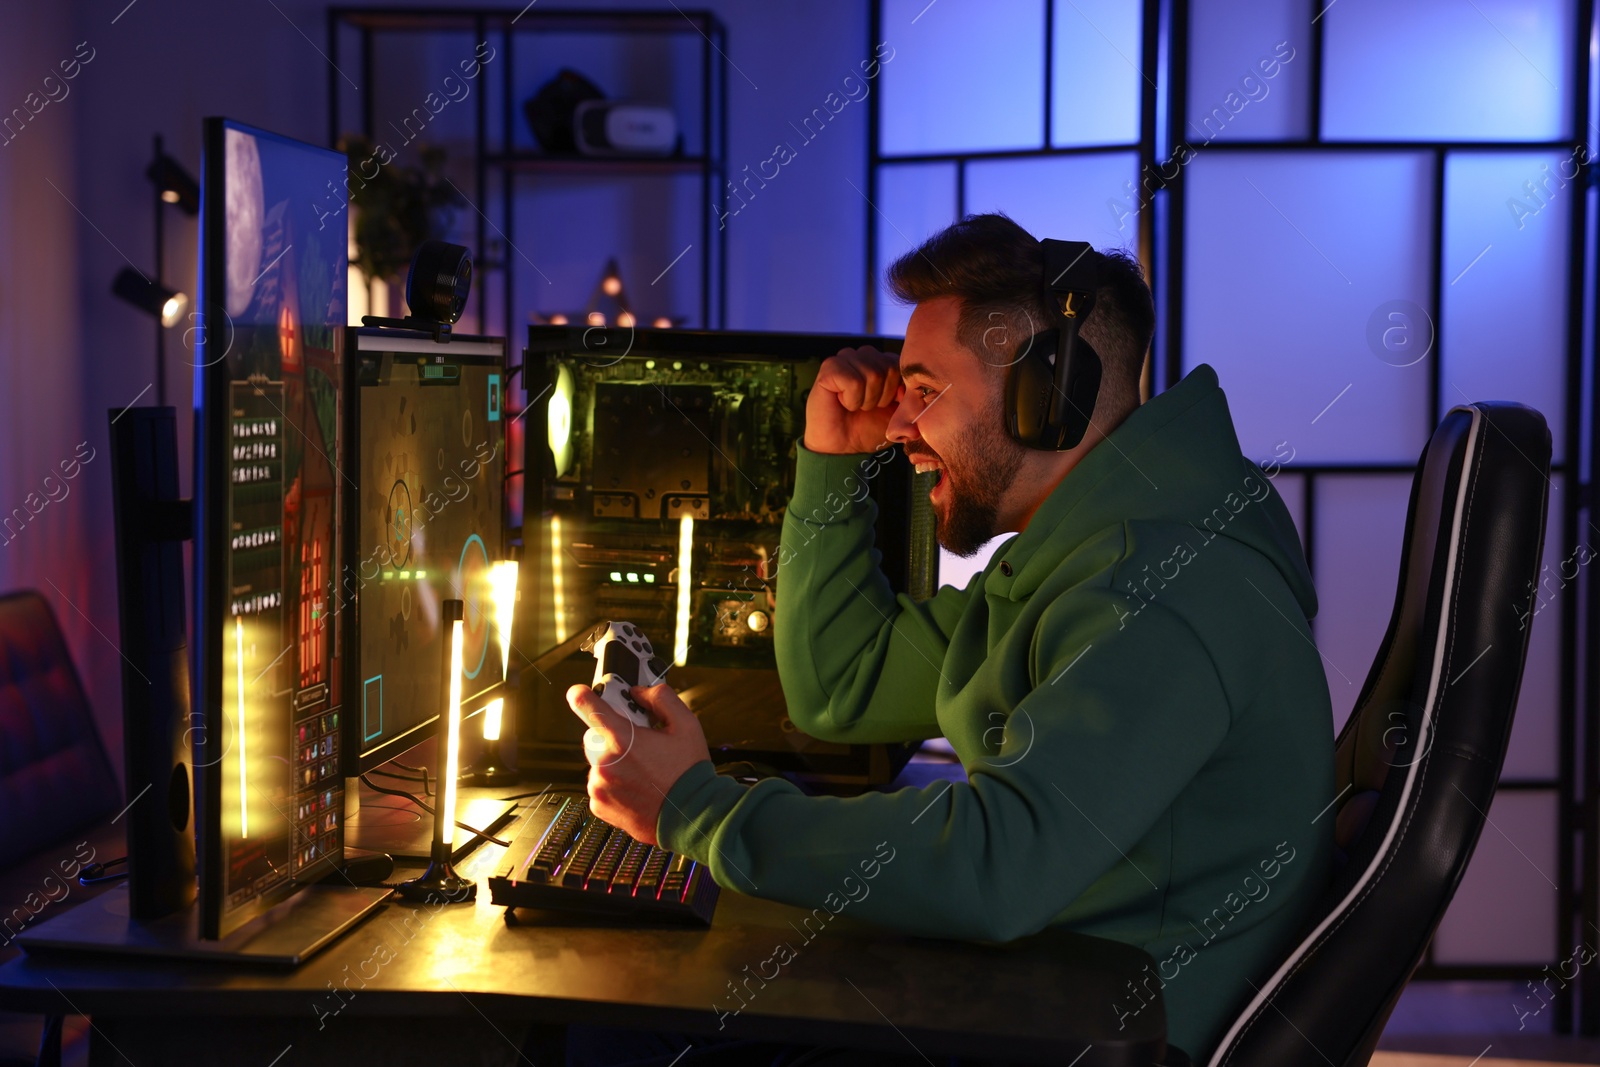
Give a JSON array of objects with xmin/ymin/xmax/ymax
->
[{"xmin": 864, "ymin": 0, "xmax": 1600, "ymax": 1033}]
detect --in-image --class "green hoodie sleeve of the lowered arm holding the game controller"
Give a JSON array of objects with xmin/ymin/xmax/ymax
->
[{"xmin": 658, "ymin": 589, "xmax": 1230, "ymax": 941}]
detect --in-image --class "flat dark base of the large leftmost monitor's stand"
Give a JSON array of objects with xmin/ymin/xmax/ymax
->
[{"xmin": 16, "ymin": 883, "xmax": 390, "ymax": 966}]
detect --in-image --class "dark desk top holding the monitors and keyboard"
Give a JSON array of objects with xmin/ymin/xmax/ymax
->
[{"xmin": 0, "ymin": 806, "xmax": 1165, "ymax": 1067}]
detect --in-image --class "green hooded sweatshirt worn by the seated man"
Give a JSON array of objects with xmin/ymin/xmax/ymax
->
[{"xmin": 658, "ymin": 366, "xmax": 1333, "ymax": 1057}]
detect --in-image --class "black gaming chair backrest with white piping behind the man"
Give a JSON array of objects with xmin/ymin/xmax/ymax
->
[{"xmin": 1206, "ymin": 403, "xmax": 1550, "ymax": 1067}]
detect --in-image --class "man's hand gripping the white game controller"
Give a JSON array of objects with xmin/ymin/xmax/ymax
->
[{"xmin": 566, "ymin": 683, "xmax": 710, "ymax": 845}]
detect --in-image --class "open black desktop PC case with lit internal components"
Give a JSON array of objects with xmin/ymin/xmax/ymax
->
[{"xmin": 517, "ymin": 326, "xmax": 939, "ymax": 792}]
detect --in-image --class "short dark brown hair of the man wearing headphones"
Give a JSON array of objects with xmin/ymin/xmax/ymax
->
[{"xmin": 888, "ymin": 213, "xmax": 1155, "ymax": 424}]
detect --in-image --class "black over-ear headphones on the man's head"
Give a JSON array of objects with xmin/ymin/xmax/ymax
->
[{"xmin": 1005, "ymin": 238, "xmax": 1101, "ymax": 453}]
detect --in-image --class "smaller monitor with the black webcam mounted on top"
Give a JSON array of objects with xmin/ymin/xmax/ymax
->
[{"xmin": 342, "ymin": 328, "xmax": 506, "ymax": 777}]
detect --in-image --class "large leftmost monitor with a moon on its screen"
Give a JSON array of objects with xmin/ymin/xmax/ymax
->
[{"xmin": 194, "ymin": 118, "xmax": 354, "ymax": 937}]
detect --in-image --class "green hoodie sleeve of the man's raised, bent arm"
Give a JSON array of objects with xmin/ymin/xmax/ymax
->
[{"xmin": 773, "ymin": 446, "xmax": 968, "ymax": 744}]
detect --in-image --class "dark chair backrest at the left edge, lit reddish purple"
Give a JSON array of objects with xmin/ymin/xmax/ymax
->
[{"xmin": 0, "ymin": 590, "xmax": 122, "ymax": 867}]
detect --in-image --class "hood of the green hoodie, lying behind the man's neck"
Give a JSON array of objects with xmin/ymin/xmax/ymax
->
[{"xmin": 984, "ymin": 363, "xmax": 1317, "ymax": 619}]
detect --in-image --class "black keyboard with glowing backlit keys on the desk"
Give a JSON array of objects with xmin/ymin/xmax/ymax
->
[{"xmin": 490, "ymin": 795, "xmax": 720, "ymax": 926}]
